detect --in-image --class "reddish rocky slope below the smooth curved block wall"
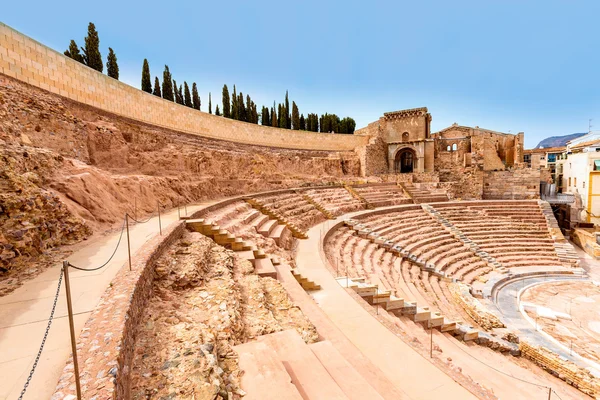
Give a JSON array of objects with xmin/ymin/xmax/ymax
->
[{"xmin": 0, "ymin": 76, "xmax": 359, "ymax": 296}]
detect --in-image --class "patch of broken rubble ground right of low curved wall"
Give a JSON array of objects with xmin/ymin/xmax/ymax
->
[{"xmin": 132, "ymin": 232, "xmax": 318, "ymax": 400}]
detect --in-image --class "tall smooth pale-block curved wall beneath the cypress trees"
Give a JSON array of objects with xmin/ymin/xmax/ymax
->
[{"xmin": 0, "ymin": 22, "xmax": 369, "ymax": 151}]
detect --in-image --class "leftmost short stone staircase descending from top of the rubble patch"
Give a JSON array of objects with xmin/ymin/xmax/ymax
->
[{"xmin": 186, "ymin": 218, "xmax": 279, "ymax": 279}]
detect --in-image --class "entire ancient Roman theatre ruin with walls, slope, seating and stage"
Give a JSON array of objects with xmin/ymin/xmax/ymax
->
[{"xmin": 0, "ymin": 24, "xmax": 600, "ymax": 400}]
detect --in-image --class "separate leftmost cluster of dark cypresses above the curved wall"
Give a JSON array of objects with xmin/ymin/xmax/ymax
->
[{"xmin": 64, "ymin": 22, "xmax": 119, "ymax": 80}]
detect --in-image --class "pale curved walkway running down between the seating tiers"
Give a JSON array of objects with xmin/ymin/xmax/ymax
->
[{"xmin": 296, "ymin": 219, "xmax": 476, "ymax": 400}]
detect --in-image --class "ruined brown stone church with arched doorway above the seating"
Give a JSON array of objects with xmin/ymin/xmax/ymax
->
[{"xmin": 355, "ymin": 107, "xmax": 524, "ymax": 175}]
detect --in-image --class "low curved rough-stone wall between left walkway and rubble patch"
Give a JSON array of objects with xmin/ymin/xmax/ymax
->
[{"xmin": 52, "ymin": 222, "xmax": 185, "ymax": 400}]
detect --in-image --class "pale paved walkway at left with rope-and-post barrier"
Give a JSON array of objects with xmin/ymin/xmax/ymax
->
[{"xmin": 0, "ymin": 203, "xmax": 210, "ymax": 400}]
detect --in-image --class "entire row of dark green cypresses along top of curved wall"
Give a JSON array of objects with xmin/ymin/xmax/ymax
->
[{"xmin": 64, "ymin": 22, "xmax": 356, "ymax": 134}]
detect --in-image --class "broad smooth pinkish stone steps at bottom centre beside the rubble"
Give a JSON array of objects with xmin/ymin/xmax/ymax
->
[{"xmin": 233, "ymin": 330, "xmax": 383, "ymax": 400}]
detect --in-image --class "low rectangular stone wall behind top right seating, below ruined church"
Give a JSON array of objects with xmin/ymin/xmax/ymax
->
[{"xmin": 483, "ymin": 168, "xmax": 540, "ymax": 200}]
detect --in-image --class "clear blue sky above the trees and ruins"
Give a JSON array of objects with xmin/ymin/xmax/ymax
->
[{"xmin": 0, "ymin": 0, "xmax": 600, "ymax": 147}]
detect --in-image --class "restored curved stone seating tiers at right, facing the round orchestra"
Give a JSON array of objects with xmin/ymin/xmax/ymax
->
[{"xmin": 324, "ymin": 202, "xmax": 560, "ymax": 334}]
